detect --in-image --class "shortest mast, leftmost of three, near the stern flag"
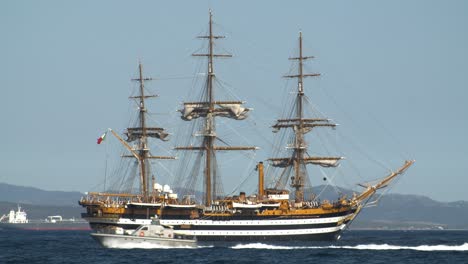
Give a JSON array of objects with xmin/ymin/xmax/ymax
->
[{"xmin": 122, "ymin": 63, "xmax": 175, "ymax": 201}]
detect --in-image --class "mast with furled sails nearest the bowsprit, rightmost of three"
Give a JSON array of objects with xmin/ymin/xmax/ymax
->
[{"xmin": 269, "ymin": 32, "xmax": 342, "ymax": 203}]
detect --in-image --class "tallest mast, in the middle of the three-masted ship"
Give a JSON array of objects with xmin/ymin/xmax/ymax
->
[{"xmin": 176, "ymin": 10, "xmax": 256, "ymax": 206}]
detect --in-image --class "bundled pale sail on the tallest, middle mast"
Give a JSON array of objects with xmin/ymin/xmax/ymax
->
[{"xmin": 180, "ymin": 101, "xmax": 250, "ymax": 121}]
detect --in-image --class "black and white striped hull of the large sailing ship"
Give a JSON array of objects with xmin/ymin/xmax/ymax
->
[{"xmin": 86, "ymin": 210, "xmax": 355, "ymax": 241}]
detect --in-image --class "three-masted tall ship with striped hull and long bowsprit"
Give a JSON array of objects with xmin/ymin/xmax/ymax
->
[{"xmin": 79, "ymin": 11, "xmax": 414, "ymax": 241}]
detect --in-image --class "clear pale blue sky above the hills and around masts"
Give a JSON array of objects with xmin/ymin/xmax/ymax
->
[{"xmin": 0, "ymin": 0, "xmax": 468, "ymax": 201}]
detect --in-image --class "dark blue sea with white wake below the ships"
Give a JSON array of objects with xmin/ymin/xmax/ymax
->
[{"xmin": 0, "ymin": 230, "xmax": 468, "ymax": 264}]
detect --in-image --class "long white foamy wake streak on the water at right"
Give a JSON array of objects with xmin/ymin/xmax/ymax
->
[{"xmin": 231, "ymin": 243, "xmax": 468, "ymax": 251}]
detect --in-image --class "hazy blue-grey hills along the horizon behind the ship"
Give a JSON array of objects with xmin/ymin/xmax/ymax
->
[{"xmin": 0, "ymin": 183, "xmax": 468, "ymax": 229}]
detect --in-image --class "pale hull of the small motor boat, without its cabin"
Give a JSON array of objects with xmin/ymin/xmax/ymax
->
[{"xmin": 91, "ymin": 233, "xmax": 197, "ymax": 249}]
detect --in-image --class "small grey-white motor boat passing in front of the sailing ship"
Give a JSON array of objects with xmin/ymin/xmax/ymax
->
[{"xmin": 91, "ymin": 219, "xmax": 197, "ymax": 248}]
